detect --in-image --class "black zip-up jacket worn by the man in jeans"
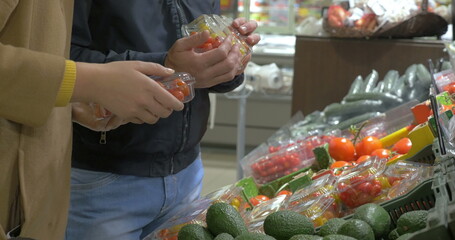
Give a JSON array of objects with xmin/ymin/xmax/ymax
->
[{"xmin": 71, "ymin": 0, "xmax": 243, "ymax": 177}]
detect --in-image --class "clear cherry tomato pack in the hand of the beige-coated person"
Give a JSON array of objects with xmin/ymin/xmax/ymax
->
[{"xmin": 152, "ymin": 72, "xmax": 196, "ymax": 103}]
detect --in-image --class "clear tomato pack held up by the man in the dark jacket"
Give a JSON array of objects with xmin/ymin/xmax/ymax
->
[{"xmin": 182, "ymin": 14, "xmax": 251, "ymax": 64}]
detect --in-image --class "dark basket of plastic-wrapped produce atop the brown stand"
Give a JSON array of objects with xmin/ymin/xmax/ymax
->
[{"xmin": 323, "ymin": 0, "xmax": 449, "ymax": 38}]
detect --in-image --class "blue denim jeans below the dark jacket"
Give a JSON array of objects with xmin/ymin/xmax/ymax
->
[{"xmin": 66, "ymin": 155, "xmax": 204, "ymax": 240}]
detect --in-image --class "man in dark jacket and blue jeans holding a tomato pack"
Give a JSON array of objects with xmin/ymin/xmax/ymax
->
[{"xmin": 67, "ymin": 0, "xmax": 259, "ymax": 240}]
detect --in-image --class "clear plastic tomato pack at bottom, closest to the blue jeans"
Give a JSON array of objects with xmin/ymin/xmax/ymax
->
[{"xmin": 143, "ymin": 199, "xmax": 212, "ymax": 240}]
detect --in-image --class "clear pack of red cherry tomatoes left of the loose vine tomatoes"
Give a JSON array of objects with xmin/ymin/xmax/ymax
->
[{"xmin": 242, "ymin": 145, "xmax": 314, "ymax": 184}]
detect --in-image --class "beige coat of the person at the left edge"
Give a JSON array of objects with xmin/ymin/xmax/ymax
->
[{"xmin": 0, "ymin": 0, "xmax": 73, "ymax": 240}]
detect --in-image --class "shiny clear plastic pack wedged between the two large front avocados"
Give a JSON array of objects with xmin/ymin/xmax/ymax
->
[{"xmin": 244, "ymin": 195, "xmax": 288, "ymax": 232}]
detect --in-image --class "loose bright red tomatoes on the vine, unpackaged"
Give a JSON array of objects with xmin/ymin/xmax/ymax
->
[{"xmin": 328, "ymin": 125, "xmax": 412, "ymax": 169}]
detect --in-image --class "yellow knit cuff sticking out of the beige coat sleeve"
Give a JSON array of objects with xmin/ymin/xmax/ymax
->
[{"xmin": 55, "ymin": 60, "xmax": 76, "ymax": 107}]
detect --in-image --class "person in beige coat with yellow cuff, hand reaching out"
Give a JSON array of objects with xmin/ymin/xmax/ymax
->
[{"xmin": 0, "ymin": 0, "xmax": 183, "ymax": 240}]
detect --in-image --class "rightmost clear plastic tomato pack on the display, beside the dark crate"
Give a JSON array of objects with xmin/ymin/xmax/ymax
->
[{"xmin": 384, "ymin": 161, "xmax": 434, "ymax": 200}]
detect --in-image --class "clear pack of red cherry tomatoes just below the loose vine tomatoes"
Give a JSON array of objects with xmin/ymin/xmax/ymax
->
[{"xmin": 337, "ymin": 157, "xmax": 387, "ymax": 209}]
